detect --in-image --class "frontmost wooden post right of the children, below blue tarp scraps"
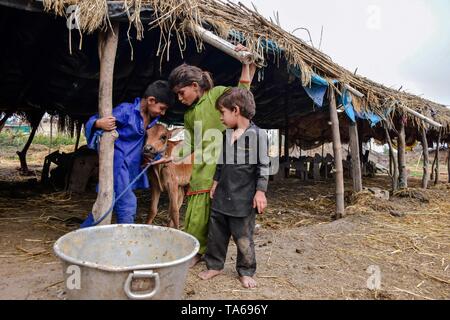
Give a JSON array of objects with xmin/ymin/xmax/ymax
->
[{"xmin": 329, "ymin": 86, "xmax": 345, "ymax": 219}]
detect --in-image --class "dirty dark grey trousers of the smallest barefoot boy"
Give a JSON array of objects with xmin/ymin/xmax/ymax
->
[{"xmin": 204, "ymin": 210, "xmax": 256, "ymax": 277}]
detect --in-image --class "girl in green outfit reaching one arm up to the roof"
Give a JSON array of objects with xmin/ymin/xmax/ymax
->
[{"xmin": 169, "ymin": 45, "xmax": 256, "ymax": 266}]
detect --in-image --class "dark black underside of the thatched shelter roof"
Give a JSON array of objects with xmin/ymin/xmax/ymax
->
[{"xmin": 0, "ymin": 7, "xmax": 432, "ymax": 150}]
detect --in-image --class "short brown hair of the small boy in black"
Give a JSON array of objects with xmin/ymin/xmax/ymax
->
[{"xmin": 216, "ymin": 88, "xmax": 256, "ymax": 120}]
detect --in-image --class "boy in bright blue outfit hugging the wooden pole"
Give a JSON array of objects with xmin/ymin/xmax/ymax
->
[{"xmin": 80, "ymin": 80, "xmax": 174, "ymax": 228}]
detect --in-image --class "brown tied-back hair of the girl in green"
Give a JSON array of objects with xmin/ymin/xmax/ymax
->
[{"xmin": 169, "ymin": 63, "xmax": 214, "ymax": 91}]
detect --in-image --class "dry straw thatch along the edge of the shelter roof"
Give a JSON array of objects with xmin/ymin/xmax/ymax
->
[{"xmin": 39, "ymin": 0, "xmax": 450, "ymax": 134}]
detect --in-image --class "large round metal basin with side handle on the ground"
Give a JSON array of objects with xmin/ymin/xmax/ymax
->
[{"xmin": 54, "ymin": 225, "xmax": 200, "ymax": 300}]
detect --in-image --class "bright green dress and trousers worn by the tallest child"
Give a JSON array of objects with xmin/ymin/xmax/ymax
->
[{"xmin": 178, "ymin": 83, "xmax": 249, "ymax": 254}]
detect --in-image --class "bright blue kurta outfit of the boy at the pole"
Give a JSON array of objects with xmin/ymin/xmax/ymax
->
[{"xmin": 81, "ymin": 98, "xmax": 159, "ymax": 227}]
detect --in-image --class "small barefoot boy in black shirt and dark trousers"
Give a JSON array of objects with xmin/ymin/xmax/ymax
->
[{"xmin": 199, "ymin": 88, "xmax": 270, "ymax": 288}]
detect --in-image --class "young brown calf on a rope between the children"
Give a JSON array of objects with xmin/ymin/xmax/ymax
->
[{"xmin": 144, "ymin": 124, "xmax": 193, "ymax": 229}]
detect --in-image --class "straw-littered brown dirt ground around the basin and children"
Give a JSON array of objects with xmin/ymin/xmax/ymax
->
[{"xmin": 0, "ymin": 147, "xmax": 450, "ymax": 300}]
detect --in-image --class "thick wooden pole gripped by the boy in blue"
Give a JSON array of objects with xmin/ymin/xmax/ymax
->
[{"xmin": 92, "ymin": 22, "xmax": 119, "ymax": 225}]
